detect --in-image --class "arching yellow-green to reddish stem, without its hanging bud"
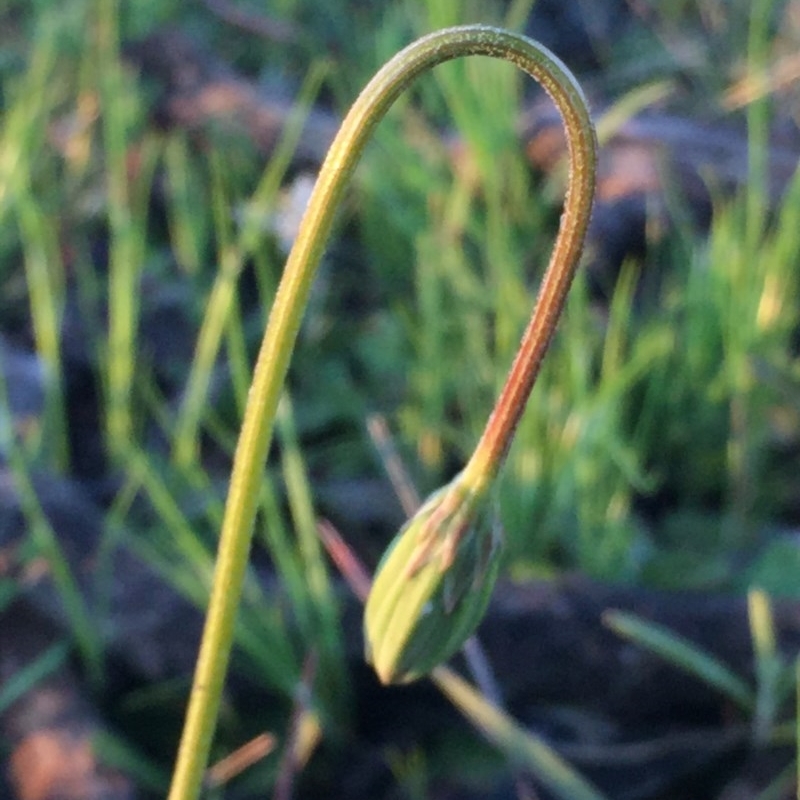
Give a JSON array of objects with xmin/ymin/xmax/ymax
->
[{"xmin": 169, "ymin": 25, "xmax": 596, "ymax": 800}]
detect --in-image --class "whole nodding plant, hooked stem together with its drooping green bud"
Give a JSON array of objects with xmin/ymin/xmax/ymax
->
[{"xmin": 169, "ymin": 25, "xmax": 596, "ymax": 800}]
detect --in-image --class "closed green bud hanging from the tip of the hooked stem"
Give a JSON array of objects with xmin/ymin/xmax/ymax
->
[{"xmin": 364, "ymin": 476, "xmax": 501, "ymax": 683}]
